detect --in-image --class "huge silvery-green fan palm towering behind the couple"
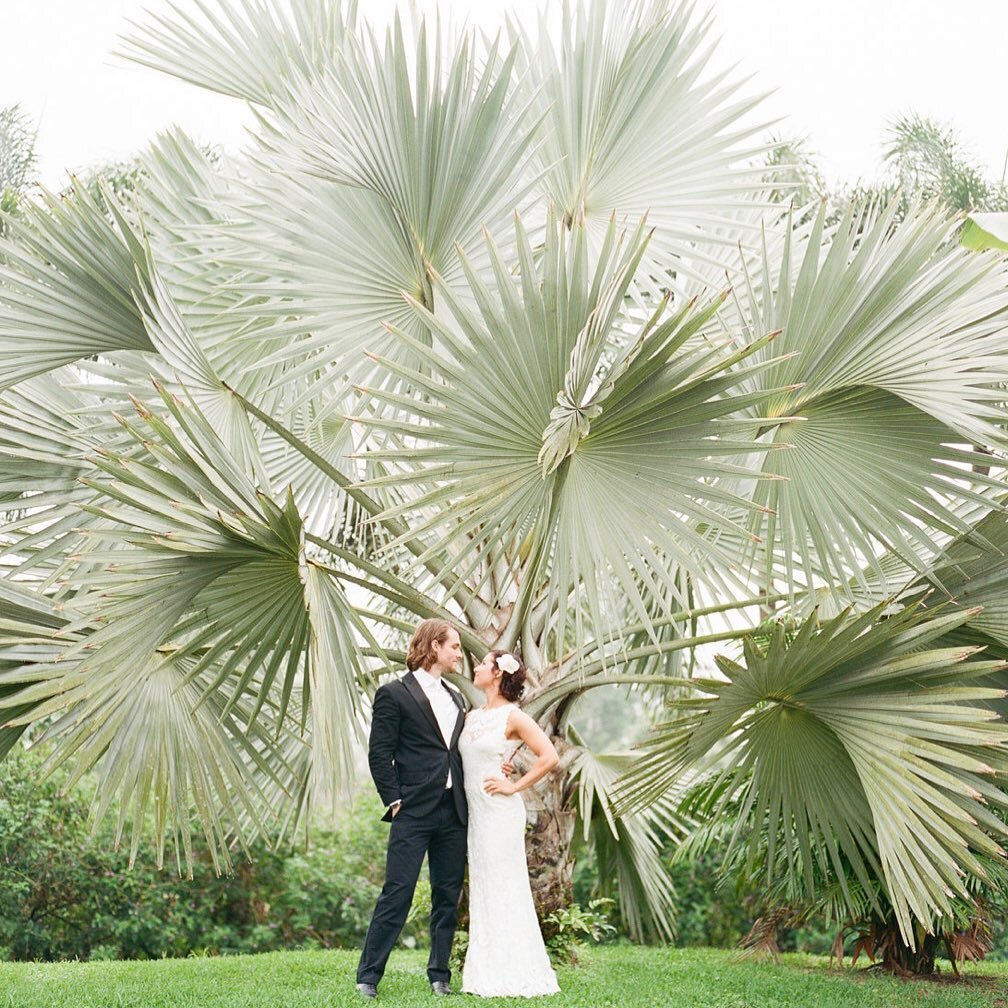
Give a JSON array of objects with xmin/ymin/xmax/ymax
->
[{"xmin": 0, "ymin": 0, "xmax": 1008, "ymax": 951}]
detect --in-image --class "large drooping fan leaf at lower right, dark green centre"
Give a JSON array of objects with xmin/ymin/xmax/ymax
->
[{"xmin": 617, "ymin": 605, "xmax": 1008, "ymax": 943}]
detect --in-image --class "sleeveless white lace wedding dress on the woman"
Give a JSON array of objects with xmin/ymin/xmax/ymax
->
[{"xmin": 459, "ymin": 704, "xmax": 559, "ymax": 997}]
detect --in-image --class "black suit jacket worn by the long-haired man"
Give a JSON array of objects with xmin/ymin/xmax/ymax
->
[{"xmin": 368, "ymin": 672, "xmax": 469, "ymax": 823}]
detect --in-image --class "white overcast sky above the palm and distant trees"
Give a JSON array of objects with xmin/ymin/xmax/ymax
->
[{"xmin": 7, "ymin": 0, "xmax": 1008, "ymax": 186}]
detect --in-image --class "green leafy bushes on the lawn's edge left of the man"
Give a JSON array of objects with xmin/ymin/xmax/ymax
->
[{"xmin": 0, "ymin": 749, "xmax": 430, "ymax": 960}]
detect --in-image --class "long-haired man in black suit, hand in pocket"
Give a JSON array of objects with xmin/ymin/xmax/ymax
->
[{"xmin": 357, "ymin": 620, "xmax": 468, "ymax": 998}]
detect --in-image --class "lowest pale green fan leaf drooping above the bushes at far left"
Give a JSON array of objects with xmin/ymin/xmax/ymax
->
[{"xmin": 0, "ymin": 568, "xmax": 304, "ymax": 872}]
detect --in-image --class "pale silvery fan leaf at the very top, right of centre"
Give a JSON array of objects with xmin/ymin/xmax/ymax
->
[{"xmin": 515, "ymin": 0, "xmax": 766, "ymax": 285}]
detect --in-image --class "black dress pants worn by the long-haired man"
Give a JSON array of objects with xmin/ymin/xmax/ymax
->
[{"xmin": 357, "ymin": 789, "xmax": 466, "ymax": 984}]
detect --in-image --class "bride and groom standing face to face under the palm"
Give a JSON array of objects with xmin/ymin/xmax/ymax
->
[{"xmin": 357, "ymin": 620, "xmax": 559, "ymax": 998}]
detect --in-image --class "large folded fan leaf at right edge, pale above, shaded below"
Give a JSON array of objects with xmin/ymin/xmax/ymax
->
[{"xmin": 729, "ymin": 198, "xmax": 1008, "ymax": 594}]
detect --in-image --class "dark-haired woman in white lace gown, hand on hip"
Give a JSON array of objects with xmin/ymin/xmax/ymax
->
[{"xmin": 459, "ymin": 651, "xmax": 559, "ymax": 997}]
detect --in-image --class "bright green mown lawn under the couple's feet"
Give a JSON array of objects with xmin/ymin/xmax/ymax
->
[{"xmin": 0, "ymin": 947, "xmax": 1008, "ymax": 1008}]
